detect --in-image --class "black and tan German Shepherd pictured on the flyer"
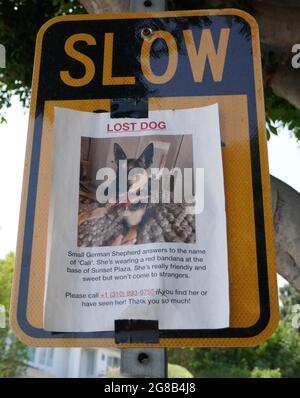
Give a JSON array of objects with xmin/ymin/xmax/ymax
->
[{"xmin": 78, "ymin": 143, "xmax": 154, "ymax": 245}]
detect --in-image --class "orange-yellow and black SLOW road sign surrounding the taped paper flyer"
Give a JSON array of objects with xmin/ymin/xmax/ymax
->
[{"xmin": 12, "ymin": 10, "xmax": 278, "ymax": 346}]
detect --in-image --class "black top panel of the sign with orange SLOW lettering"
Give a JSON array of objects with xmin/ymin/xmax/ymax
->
[{"xmin": 38, "ymin": 15, "xmax": 255, "ymax": 102}]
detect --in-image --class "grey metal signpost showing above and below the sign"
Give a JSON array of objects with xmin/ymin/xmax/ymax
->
[{"xmin": 121, "ymin": 0, "xmax": 168, "ymax": 378}]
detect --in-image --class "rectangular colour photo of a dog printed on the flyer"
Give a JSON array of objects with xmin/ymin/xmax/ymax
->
[{"xmin": 78, "ymin": 135, "xmax": 195, "ymax": 247}]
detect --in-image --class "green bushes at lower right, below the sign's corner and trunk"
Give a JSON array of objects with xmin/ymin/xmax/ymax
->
[{"xmin": 169, "ymin": 285, "xmax": 300, "ymax": 378}]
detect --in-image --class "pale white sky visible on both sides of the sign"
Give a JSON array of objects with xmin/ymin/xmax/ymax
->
[{"xmin": 0, "ymin": 98, "xmax": 300, "ymax": 285}]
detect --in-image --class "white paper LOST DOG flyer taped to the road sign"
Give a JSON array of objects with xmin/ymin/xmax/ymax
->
[{"xmin": 44, "ymin": 105, "xmax": 229, "ymax": 332}]
